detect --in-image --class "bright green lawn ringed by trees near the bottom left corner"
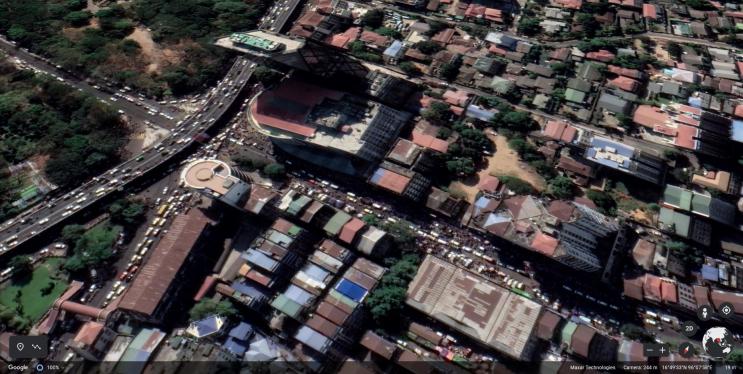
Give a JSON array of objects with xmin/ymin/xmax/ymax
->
[{"xmin": 0, "ymin": 258, "xmax": 67, "ymax": 321}]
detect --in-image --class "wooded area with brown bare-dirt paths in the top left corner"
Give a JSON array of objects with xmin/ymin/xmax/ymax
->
[{"xmin": 0, "ymin": 0, "xmax": 268, "ymax": 97}]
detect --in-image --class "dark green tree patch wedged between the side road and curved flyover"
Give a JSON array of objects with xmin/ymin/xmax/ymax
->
[{"xmin": 0, "ymin": 59, "xmax": 128, "ymax": 221}]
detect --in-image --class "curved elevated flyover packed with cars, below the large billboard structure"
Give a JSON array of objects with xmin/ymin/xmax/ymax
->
[{"xmin": 0, "ymin": 58, "xmax": 255, "ymax": 255}]
